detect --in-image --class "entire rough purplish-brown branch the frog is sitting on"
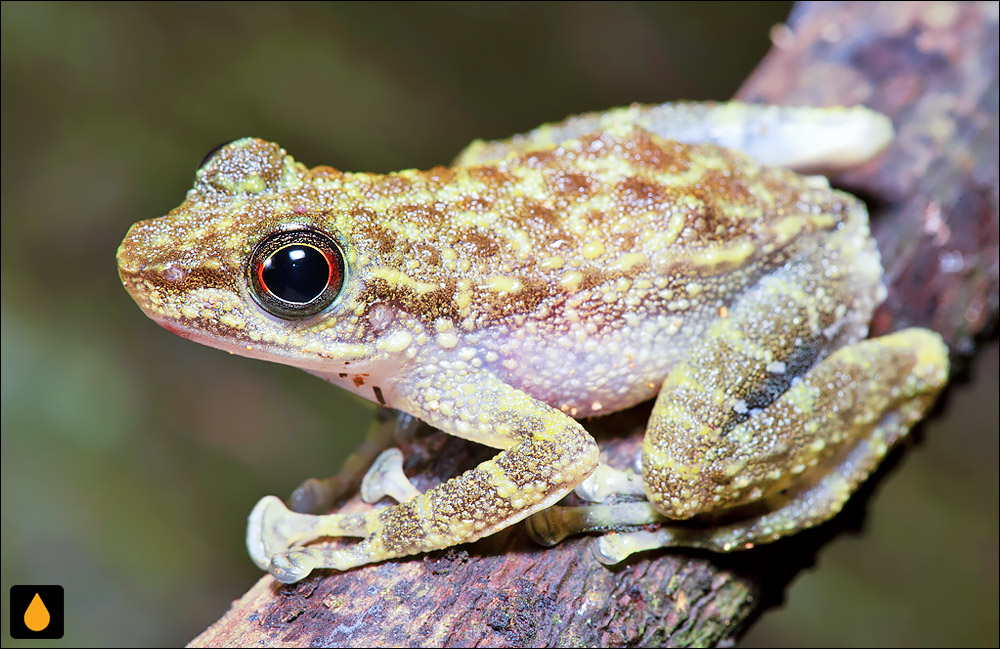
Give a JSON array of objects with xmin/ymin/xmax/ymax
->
[{"xmin": 192, "ymin": 3, "xmax": 998, "ymax": 646}]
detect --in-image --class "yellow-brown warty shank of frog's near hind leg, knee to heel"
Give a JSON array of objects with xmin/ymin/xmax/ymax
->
[{"xmin": 643, "ymin": 322, "xmax": 948, "ymax": 524}]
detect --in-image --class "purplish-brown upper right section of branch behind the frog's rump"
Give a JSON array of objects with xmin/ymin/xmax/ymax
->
[{"xmin": 738, "ymin": 2, "xmax": 998, "ymax": 355}]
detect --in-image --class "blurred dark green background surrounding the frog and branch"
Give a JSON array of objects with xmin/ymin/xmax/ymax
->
[{"xmin": 0, "ymin": 2, "xmax": 998, "ymax": 646}]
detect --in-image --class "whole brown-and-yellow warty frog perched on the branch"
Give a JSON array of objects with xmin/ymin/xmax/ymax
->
[{"xmin": 117, "ymin": 102, "xmax": 949, "ymax": 583}]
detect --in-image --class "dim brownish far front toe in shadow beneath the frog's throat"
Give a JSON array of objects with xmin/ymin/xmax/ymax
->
[{"xmin": 288, "ymin": 408, "xmax": 420, "ymax": 514}]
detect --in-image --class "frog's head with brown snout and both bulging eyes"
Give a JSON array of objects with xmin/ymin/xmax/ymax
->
[{"xmin": 118, "ymin": 138, "xmax": 410, "ymax": 376}]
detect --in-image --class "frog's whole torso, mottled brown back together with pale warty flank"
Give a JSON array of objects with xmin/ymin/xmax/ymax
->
[{"xmin": 356, "ymin": 124, "xmax": 880, "ymax": 416}]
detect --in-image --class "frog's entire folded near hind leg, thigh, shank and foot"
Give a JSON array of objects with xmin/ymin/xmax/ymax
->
[{"xmin": 532, "ymin": 208, "xmax": 948, "ymax": 554}]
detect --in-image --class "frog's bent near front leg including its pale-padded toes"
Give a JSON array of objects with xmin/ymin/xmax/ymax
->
[{"xmin": 247, "ymin": 365, "xmax": 598, "ymax": 583}]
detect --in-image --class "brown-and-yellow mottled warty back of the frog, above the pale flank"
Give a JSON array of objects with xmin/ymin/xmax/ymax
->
[{"xmin": 342, "ymin": 125, "xmax": 865, "ymax": 331}]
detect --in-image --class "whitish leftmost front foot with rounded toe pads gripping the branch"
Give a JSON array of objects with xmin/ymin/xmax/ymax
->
[{"xmin": 247, "ymin": 496, "xmax": 370, "ymax": 570}]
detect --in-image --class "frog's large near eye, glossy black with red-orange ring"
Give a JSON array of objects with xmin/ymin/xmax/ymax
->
[{"xmin": 247, "ymin": 229, "xmax": 345, "ymax": 319}]
